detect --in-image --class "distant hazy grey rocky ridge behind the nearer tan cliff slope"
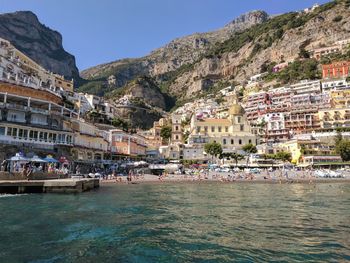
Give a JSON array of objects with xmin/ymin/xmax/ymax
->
[{"xmin": 81, "ymin": 11, "xmax": 268, "ymax": 87}]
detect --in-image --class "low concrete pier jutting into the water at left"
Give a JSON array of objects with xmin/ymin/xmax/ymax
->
[{"xmin": 0, "ymin": 178, "xmax": 100, "ymax": 194}]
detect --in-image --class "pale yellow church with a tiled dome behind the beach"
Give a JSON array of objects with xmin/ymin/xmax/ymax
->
[{"xmin": 189, "ymin": 104, "xmax": 256, "ymax": 152}]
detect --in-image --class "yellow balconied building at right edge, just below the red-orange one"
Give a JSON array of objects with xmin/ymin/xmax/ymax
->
[{"xmin": 318, "ymin": 108, "xmax": 350, "ymax": 130}]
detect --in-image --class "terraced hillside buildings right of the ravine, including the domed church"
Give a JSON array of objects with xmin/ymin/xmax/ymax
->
[{"xmin": 141, "ymin": 36, "xmax": 350, "ymax": 168}]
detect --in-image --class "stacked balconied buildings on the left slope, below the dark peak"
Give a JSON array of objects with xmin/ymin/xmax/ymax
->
[{"xmin": 0, "ymin": 39, "xmax": 146, "ymax": 173}]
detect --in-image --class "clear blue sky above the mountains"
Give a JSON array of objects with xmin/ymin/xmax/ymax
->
[{"xmin": 0, "ymin": 0, "xmax": 329, "ymax": 70}]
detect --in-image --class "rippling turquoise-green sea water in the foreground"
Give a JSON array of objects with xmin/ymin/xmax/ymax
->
[{"xmin": 0, "ymin": 183, "xmax": 350, "ymax": 263}]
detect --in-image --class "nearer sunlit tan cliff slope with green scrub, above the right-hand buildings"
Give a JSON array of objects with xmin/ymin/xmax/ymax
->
[{"xmin": 168, "ymin": 1, "xmax": 350, "ymax": 98}]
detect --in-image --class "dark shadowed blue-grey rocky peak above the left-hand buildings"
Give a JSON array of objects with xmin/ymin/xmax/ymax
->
[{"xmin": 0, "ymin": 11, "xmax": 79, "ymax": 80}]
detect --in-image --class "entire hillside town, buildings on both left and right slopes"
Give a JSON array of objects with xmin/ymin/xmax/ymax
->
[{"xmin": 0, "ymin": 34, "xmax": 350, "ymax": 176}]
